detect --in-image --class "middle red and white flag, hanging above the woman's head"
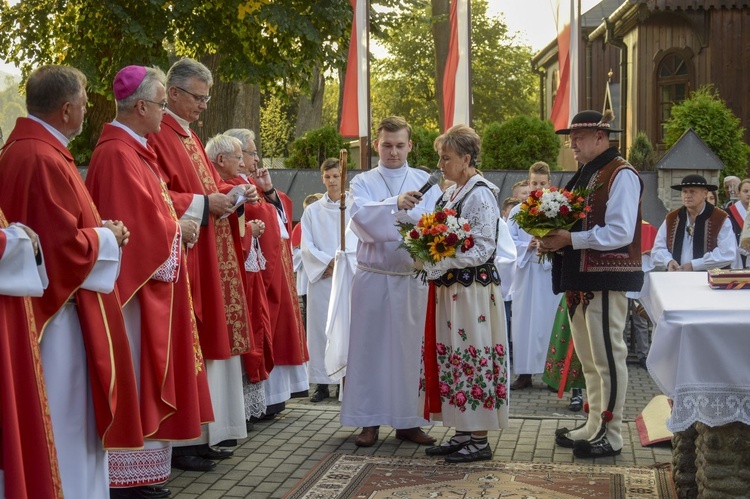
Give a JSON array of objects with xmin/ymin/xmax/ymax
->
[{"xmin": 443, "ymin": 0, "xmax": 471, "ymax": 131}]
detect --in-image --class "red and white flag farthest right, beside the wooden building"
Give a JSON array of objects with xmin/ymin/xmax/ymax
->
[{"xmin": 550, "ymin": 0, "xmax": 580, "ymax": 129}]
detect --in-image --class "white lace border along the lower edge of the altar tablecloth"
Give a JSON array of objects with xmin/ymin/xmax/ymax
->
[{"xmin": 667, "ymin": 385, "xmax": 750, "ymax": 432}]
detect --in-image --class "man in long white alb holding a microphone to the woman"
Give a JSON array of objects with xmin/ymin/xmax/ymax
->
[{"xmin": 341, "ymin": 117, "xmax": 441, "ymax": 447}]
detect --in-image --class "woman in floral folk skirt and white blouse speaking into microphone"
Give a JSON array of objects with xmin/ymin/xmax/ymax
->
[{"xmin": 420, "ymin": 125, "xmax": 515, "ymax": 462}]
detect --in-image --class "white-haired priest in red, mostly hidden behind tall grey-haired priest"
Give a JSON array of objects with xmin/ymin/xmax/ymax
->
[{"xmin": 206, "ymin": 134, "xmax": 278, "ymax": 424}]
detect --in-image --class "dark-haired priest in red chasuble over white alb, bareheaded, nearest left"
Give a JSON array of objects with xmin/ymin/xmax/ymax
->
[{"xmin": 0, "ymin": 66, "xmax": 143, "ymax": 497}]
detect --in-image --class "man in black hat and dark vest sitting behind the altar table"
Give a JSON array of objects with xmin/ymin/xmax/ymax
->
[{"xmin": 651, "ymin": 175, "xmax": 737, "ymax": 272}]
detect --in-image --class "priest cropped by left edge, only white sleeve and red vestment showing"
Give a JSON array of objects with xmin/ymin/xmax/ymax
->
[{"xmin": 0, "ymin": 215, "xmax": 62, "ymax": 498}]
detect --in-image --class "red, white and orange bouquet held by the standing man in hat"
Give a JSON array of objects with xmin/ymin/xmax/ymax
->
[{"xmin": 513, "ymin": 187, "xmax": 591, "ymax": 259}]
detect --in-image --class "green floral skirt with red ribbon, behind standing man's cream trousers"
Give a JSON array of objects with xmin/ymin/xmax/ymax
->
[{"xmin": 542, "ymin": 294, "xmax": 586, "ymax": 392}]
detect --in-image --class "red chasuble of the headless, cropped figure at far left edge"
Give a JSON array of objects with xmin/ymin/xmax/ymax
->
[{"xmin": 0, "ymin": 211, "xmax": 63, "ymax": 498}]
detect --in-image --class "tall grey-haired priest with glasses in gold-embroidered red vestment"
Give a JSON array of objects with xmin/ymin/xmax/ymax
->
[{"xmin": 148, "ymin": 58, "xmax": 257, "ymax": 471}]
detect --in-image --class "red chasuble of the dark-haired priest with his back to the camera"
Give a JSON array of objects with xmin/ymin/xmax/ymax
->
[{"xmin": 0, "ymin": 118, "xmax": 143, "ymax": 449}]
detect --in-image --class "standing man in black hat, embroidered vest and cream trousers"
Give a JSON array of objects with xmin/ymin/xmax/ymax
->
[{"xmin": 540, "ymin": 111, "xmax": 643, "ymax": 458}]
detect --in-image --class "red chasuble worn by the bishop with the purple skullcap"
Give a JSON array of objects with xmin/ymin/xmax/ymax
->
[{"xmin": 86, "ymin": 124, "xmax": 213, "ymax": 440}]
